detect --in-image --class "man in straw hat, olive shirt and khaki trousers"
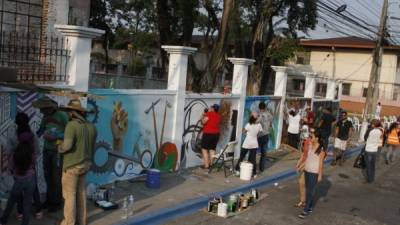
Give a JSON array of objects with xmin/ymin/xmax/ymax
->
[{"xmin": 58, "ymin": 99, "xmax": 97, "ymax": 225}]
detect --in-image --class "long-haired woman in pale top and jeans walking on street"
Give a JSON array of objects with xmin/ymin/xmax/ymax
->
[{"xmin": 299, "ymin": 129, "xmax": 326, "ymax": 219}]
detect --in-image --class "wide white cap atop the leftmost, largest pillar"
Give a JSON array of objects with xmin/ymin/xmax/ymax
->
[{"xmin": 54, "ymin": 24, "xmax": 105, "ymax": 39}]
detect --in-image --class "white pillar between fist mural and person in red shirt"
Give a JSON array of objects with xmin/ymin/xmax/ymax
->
[{"xmin": 161, "ymin": 45, "xmax": 197, "ymax": 169}]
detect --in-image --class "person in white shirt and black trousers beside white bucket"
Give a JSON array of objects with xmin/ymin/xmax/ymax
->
[{"xmin": 235, "ymin": 114, "xmax": 262, "ymax": 177}]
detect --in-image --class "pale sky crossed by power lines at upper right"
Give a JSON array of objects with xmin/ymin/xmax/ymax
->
[{"xmin": 307, "ymin": 0, "xmax": 400, "ymax": 44}]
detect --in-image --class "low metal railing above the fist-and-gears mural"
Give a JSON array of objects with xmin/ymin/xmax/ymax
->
[{"xmin": 89, "ymin": 72, "xmax": 167, "ymax": 89}]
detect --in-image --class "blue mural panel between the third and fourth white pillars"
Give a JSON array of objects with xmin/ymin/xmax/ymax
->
[{"xmin": 242, "ymin": 96, "xmax": 281, "ymax": 150}]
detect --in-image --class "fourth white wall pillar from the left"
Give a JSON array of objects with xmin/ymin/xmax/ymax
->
[{"xmin": 272, "ymin": 66, "xmax": 288, "ymax": 148}]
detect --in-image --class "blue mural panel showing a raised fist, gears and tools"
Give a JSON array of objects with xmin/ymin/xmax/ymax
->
[{"xmin": 87, "ymin": 90, "xmax": 179, "ymax": 184}]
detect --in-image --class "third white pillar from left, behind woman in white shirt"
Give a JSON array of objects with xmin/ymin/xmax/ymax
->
[{"xmin": 228, "ymin": 58, "xmax": 255, "ymax": 156}]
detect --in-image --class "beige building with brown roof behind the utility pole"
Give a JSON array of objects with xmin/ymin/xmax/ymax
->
[{"xmin": 297, "ymin": 37, "xmax": 400, "ymax": 102}]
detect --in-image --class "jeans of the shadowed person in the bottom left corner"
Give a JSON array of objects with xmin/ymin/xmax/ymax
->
[{"xmin": 0, "ymin": 176, "xmax": 36, "ymax": 225}]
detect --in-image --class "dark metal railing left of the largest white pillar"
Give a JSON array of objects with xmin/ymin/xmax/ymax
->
[{"xmin": 0, "ymin": 32, "xmax": 70, "ymax": 83}]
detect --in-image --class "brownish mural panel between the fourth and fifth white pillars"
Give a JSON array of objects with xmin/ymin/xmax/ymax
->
[{"xmin": 281, "ymin": 97, "xmax": 315, "ymax": 144}]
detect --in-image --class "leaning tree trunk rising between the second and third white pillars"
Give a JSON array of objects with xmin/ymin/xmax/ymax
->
[{"xmin": 201, "ymin": 0, "xmax": 235, "ymax": 92}]
